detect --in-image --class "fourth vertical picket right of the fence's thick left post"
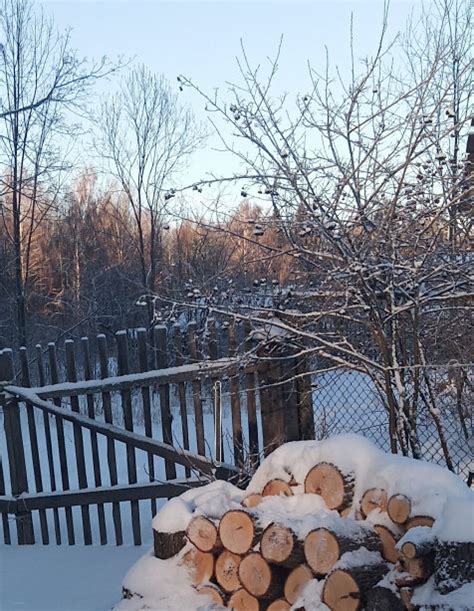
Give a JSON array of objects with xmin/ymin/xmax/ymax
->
[{"xmin": 64, "ymin": 339, "xmax": 92, "ymax": 545}]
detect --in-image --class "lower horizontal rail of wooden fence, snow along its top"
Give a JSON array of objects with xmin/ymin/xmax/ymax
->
[{"xmin": 0, "ymin": 478, "xmax": 202, "ymax": 513}]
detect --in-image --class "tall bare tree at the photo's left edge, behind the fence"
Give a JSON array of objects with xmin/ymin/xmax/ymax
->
[{"xmin": 0, "ymin": 0, "xmax": 115, "ymax": 344}]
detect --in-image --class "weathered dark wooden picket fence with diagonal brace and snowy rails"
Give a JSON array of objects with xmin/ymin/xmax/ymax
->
[{"xmin": 0, "ymin": 321, "xmax": 314, "ymax": 545}]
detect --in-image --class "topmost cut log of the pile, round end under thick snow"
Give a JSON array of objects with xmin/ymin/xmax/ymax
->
[{"xmin": 304, "ymin": 463, "xmax": 354, "ymax": 511}]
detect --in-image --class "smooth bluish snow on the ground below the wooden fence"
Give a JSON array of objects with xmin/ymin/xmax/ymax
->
[{"xmin": 0, "ymin": 545, "xmax": 144, "ymax": 611}]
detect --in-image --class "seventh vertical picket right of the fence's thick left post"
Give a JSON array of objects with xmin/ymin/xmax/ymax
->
[{"xmin": 115, "ymin": 331, "xmax": 142, "ymax": 545}]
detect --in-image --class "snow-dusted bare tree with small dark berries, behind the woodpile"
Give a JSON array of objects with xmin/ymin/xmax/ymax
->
[{"xmin": 169, "ymin": 0, "xmax": 473, "ymax": 468}]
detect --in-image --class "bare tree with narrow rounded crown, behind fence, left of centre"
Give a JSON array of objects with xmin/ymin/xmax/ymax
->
[{"xmin": 96, "ymin": 66, "xmax": 203, "ymax": 322}]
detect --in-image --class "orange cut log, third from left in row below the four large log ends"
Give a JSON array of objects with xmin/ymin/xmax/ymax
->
[{"xmin": 239, "ymin": 552, "xmax": 284, "ymax": 598}]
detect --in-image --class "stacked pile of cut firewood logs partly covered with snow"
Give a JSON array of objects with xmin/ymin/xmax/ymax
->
[{"xmin": 154, "ymin": 461, "xmax": 474, "ymax": 611}]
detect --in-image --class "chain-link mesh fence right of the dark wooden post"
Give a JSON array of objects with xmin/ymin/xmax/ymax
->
[{"xmin": 312, "ymin": 365, "xmax": 474, "ymax": 479}]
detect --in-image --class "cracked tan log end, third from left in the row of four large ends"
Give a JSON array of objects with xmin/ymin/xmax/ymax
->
[{"xmin": 260, "ymin": 524, "xmax": 304, "ymax": 568}]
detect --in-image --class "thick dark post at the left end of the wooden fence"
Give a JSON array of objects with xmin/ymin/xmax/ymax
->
[{"xmin": 0, "ymin": 349, "xmax": 35, "ymax": 545}]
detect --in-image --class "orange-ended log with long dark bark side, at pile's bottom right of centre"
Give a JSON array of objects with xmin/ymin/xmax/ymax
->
[{"xmin": 322, "ymin": 562, "xmax": 387, "ymax": 611}]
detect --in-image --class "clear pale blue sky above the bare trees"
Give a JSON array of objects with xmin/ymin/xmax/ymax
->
[{"xmin": 40, "ymin": 0, "xmax": 428, "ymax": 196}]
